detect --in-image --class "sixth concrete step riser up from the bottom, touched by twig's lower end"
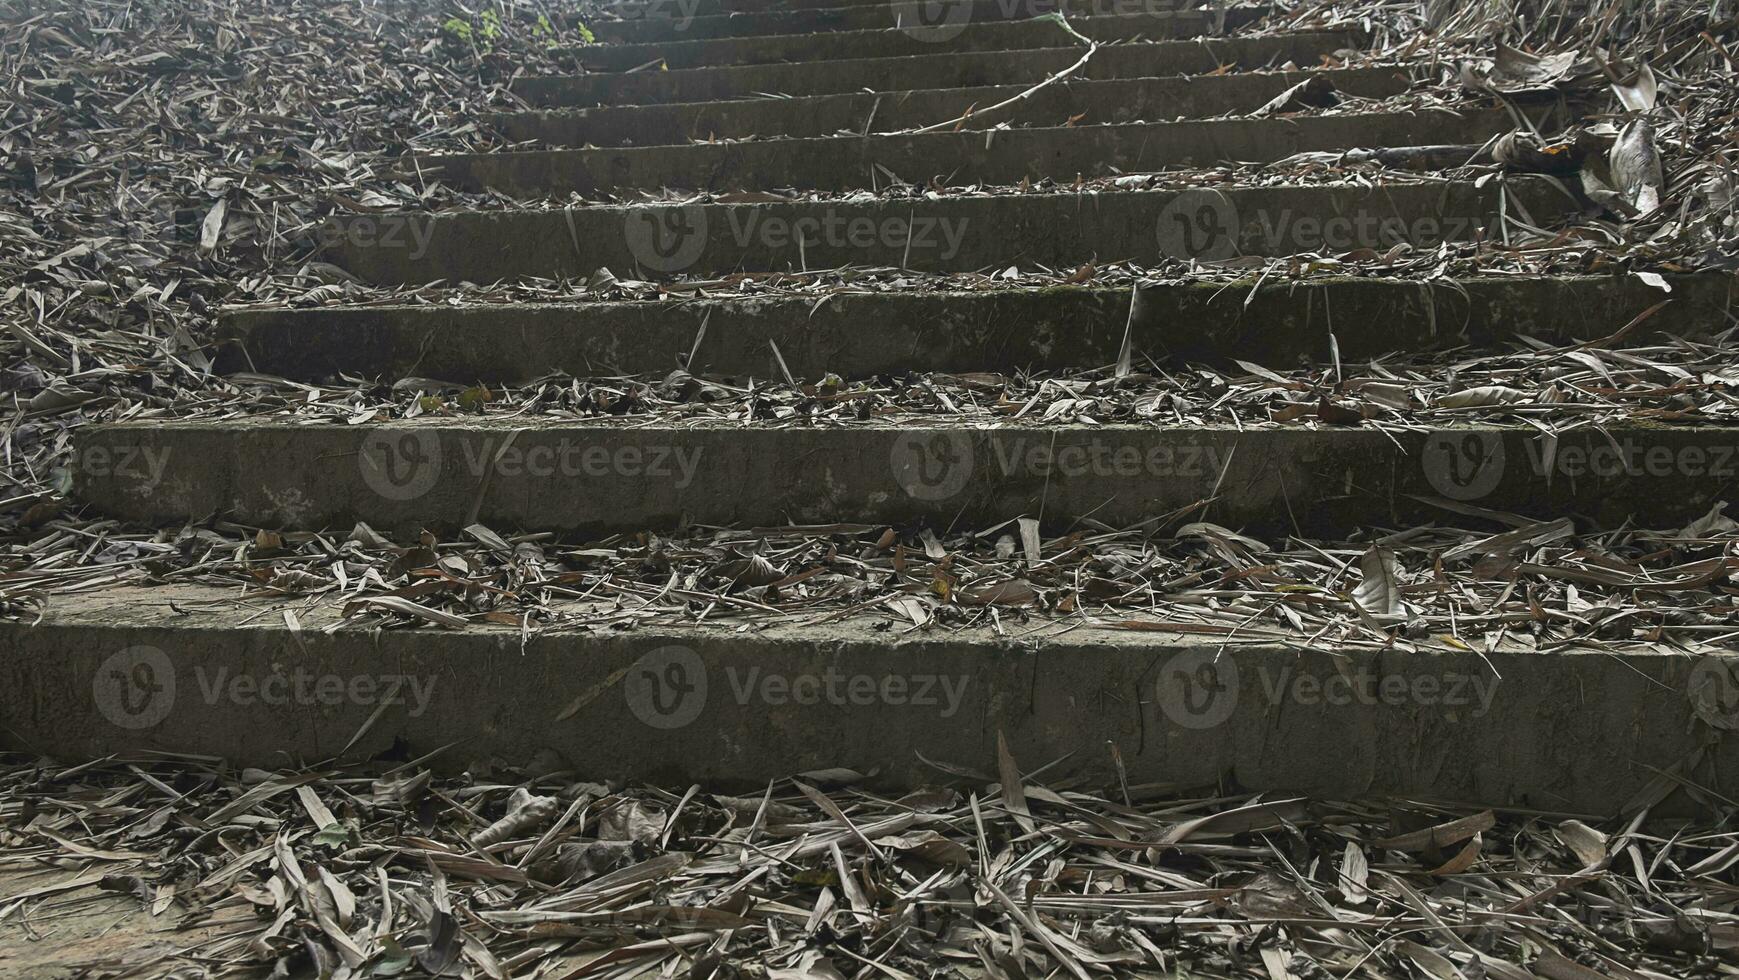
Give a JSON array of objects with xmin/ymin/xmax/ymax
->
[{"xmin": 483, "ymin": 68, "xmax": 1409, "ymax": 146}]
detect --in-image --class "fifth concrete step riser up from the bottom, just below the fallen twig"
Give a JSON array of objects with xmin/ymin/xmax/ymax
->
[{"xmin": 427, "ymin": 108, "xmax": 1530, "ymax": 200}]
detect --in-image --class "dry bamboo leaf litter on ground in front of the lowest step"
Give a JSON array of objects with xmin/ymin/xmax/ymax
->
[{"xmin": 0, "ymin": 752, "xmax": 1739, "ymax": 980}]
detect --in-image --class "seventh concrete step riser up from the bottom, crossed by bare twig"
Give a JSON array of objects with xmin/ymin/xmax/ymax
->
[{"xmin": 513, "ymin": 31, "xmax": 1360, "ymax": 108}]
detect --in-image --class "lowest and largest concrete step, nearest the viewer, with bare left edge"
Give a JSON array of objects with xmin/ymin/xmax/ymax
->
[{"xmin": 10, "ymin": 584, "xmax": 1739, "ymax": 815}]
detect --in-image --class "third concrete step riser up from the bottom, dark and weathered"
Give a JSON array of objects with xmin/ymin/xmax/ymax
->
[{"xmin": 217, "ymin": 275, "xmax": 1739, "ymax": 384}]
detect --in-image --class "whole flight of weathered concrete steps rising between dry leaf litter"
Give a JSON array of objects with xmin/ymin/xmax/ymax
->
[{"xmin": 0, "ymin": 0, "xmax": 1739, "ymax": 813}]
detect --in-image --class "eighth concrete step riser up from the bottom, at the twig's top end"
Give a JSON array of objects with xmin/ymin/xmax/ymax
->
[{"xmin": 567, "ymin": 7, "xmax": 1266, "ymax": 71}]
